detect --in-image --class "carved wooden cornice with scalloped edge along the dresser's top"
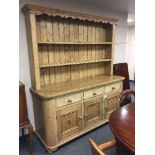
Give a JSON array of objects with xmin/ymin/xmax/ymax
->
[{"xmin": 22, "ymin": 4, "xmax": 118, "ymax": 24}]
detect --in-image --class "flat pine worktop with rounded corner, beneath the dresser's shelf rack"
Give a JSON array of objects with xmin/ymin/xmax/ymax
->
[{"xmin": 30, "ymin": 75, "xmax": 124, "ymax": 98}]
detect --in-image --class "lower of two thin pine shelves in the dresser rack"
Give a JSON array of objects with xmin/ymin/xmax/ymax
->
[{"xmin": 40, "ymin": 59, "xmax": 111, "ymax": 68}]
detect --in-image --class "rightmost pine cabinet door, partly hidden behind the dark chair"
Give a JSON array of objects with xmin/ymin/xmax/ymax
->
[{"xmin": 104, "ymin": 92, "xmax": 120, "ymax": 118}]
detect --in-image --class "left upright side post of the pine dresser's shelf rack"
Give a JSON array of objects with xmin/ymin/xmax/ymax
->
[{"xmin": 25, "ymin": 13, "xmax": 40, "ymax": 90}]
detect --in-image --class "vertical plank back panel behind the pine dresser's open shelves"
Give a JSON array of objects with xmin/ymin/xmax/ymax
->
[{"xmin": 36, "ymin": 15, "xmax": 112, "ymax": 87}]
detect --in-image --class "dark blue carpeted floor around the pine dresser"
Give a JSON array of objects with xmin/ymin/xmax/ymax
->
[{"xmin": 19, "ymin": 82, "xmax": 135, "ymax": 155}]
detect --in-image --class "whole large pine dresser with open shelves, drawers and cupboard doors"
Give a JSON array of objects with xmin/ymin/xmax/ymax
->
[{"xmin": 22, "ymin": 4, "xmax": 124, "ymax": 152}]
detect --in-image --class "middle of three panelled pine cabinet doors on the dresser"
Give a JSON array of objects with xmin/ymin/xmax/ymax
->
[{"xmin": 84, "ymin": 97, "xmax": 103, "ymax": 126}]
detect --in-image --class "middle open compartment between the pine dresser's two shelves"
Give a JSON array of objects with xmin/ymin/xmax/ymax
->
[{"xmin": 38, "ymin": 45, "xmax": 113, "ymax": 68}]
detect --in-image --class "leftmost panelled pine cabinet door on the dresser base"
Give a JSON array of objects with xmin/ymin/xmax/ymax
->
[{"xmin": 57, "ymin": 103, "xmax": 82, "ymax": 140}]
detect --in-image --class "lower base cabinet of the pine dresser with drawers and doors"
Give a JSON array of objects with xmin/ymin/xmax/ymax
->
[{"xmin": 31, "ymin": 77, "xmax": 122, "ymax": 152}]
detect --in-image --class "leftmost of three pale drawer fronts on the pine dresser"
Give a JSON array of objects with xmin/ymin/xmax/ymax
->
[{"xmin": 55, "ymin": 93, "xmax": 81, "ymax": 108}]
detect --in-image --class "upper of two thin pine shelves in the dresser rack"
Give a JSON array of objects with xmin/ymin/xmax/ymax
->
[{"xmin": 38, "ymin": 41, "xmax": 112, "ymax": 45}]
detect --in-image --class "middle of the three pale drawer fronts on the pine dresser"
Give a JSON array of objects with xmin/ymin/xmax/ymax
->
[{"xmin": 84, "ymin": 87, "xmax": 104, "ymax": 99}]
